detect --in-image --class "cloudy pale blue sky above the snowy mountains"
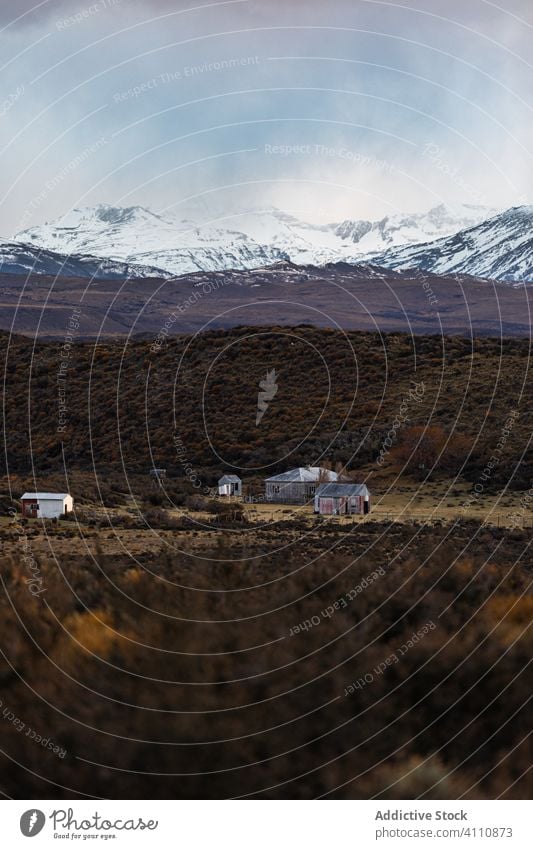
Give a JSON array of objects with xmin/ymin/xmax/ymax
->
[{"xmin": 0, "ymin": 0, "xmax": 533, "ymax": 238}]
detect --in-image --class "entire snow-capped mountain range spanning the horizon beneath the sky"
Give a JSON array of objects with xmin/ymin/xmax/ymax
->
[{"xmin": 0, "ymin": 204, "xmax": 533, "ymax": 285}]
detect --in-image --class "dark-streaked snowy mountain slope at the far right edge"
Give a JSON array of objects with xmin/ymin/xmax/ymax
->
[{"xmin": 373, "ymin": 206, "xmax": 533, "ymax": 282}]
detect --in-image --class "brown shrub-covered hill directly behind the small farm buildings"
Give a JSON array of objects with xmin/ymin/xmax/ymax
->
[{"xmin": 0, "ymin": 326, "xmax": 533, "ymax": 488}]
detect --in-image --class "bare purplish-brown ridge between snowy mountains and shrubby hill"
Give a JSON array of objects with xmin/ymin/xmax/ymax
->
[{"xmin": 0, "ymin": 260, "xmax": 533, "ymax": 340}]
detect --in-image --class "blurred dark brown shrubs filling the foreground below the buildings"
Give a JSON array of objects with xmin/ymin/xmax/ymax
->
[{"xmin": 0, "ymin": 522, "xmax": 533, "ymax": 799}]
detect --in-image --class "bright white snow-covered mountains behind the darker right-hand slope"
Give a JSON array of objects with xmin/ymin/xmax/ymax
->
[{"xmin": 11, "ymin": 204, "xmax": 493, "ymax": 275}]
